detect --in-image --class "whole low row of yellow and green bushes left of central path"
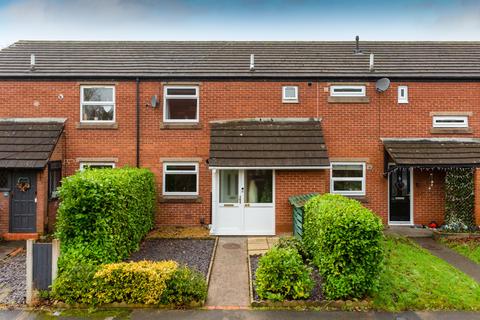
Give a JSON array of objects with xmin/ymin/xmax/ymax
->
[{"xmin": 51, "ymin": 261, "xmax": 207, "ymax": 306}]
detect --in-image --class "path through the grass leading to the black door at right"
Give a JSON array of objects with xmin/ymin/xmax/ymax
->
[{"xmin": 413, "ymin": 238, "xmax": 480, "ymax": 283}]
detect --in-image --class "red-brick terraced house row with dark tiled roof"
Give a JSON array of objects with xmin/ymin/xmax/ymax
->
[{"xmin": 0, "ymin": 41, "xmax": 480, "ymax": 238}]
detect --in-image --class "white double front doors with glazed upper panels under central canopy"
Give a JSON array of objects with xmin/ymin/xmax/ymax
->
[{"xmin": 213, "ymin": 170, "xmax": 275, "ymax": 235}]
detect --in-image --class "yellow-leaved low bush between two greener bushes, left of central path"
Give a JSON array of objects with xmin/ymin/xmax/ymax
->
[{"xmin": 93, "ymin": 261, "xmax": 177, "ymax": 304}]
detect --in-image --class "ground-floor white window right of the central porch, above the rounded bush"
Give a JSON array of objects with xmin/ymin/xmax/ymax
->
[{"xmin": 330, "ymin": 162, "xmax": 365, "ymax": 196}]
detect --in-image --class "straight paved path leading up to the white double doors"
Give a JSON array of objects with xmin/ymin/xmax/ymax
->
[{"xmin": 206, "ymin": 237, "xmax": 250, "ymax": 308}]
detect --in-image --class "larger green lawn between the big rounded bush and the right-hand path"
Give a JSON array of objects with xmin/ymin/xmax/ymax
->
[{"xmin": 373, "ymin": 237, "xmax": 480, "ymax": 311}]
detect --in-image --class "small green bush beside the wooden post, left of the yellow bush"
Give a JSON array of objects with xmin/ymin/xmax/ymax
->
[{"xmin": 50, "ymin": 263, "xmax": 98, "ymax": 304}]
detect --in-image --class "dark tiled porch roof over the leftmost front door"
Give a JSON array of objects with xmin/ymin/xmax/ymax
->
[{"xmin": 0, "ymin": 118, "xmax": 65, "ymax": 169}]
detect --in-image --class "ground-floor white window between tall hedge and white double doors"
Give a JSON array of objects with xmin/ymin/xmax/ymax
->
[{"xmin": 162, "ymin": 162, "xmax": 199, "ymax": 196}]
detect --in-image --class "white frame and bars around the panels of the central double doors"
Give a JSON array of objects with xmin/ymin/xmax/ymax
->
[{"xmin": 210, "ymin": 168, "xmax": 276, "ymax": 235}]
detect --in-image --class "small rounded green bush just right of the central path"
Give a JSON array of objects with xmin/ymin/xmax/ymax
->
[{"xmin": 255, "ymin": 247, "xmax": 314, "ymax": 301}]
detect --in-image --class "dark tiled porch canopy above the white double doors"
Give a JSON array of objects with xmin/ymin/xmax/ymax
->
[{"xmin": 208, "ymin": 118, "xmax": 330, "ymax": 169}]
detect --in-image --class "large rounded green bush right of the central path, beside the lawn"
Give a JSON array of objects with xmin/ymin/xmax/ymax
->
[{"xmin": 303, "ymin": 194, "xmax": 384, "ymax": 299}]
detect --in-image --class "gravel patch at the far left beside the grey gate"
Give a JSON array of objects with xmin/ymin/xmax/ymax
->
[{"xmin": 0, "ymin": 253, "xmax": 27, "ymax": 305}]
